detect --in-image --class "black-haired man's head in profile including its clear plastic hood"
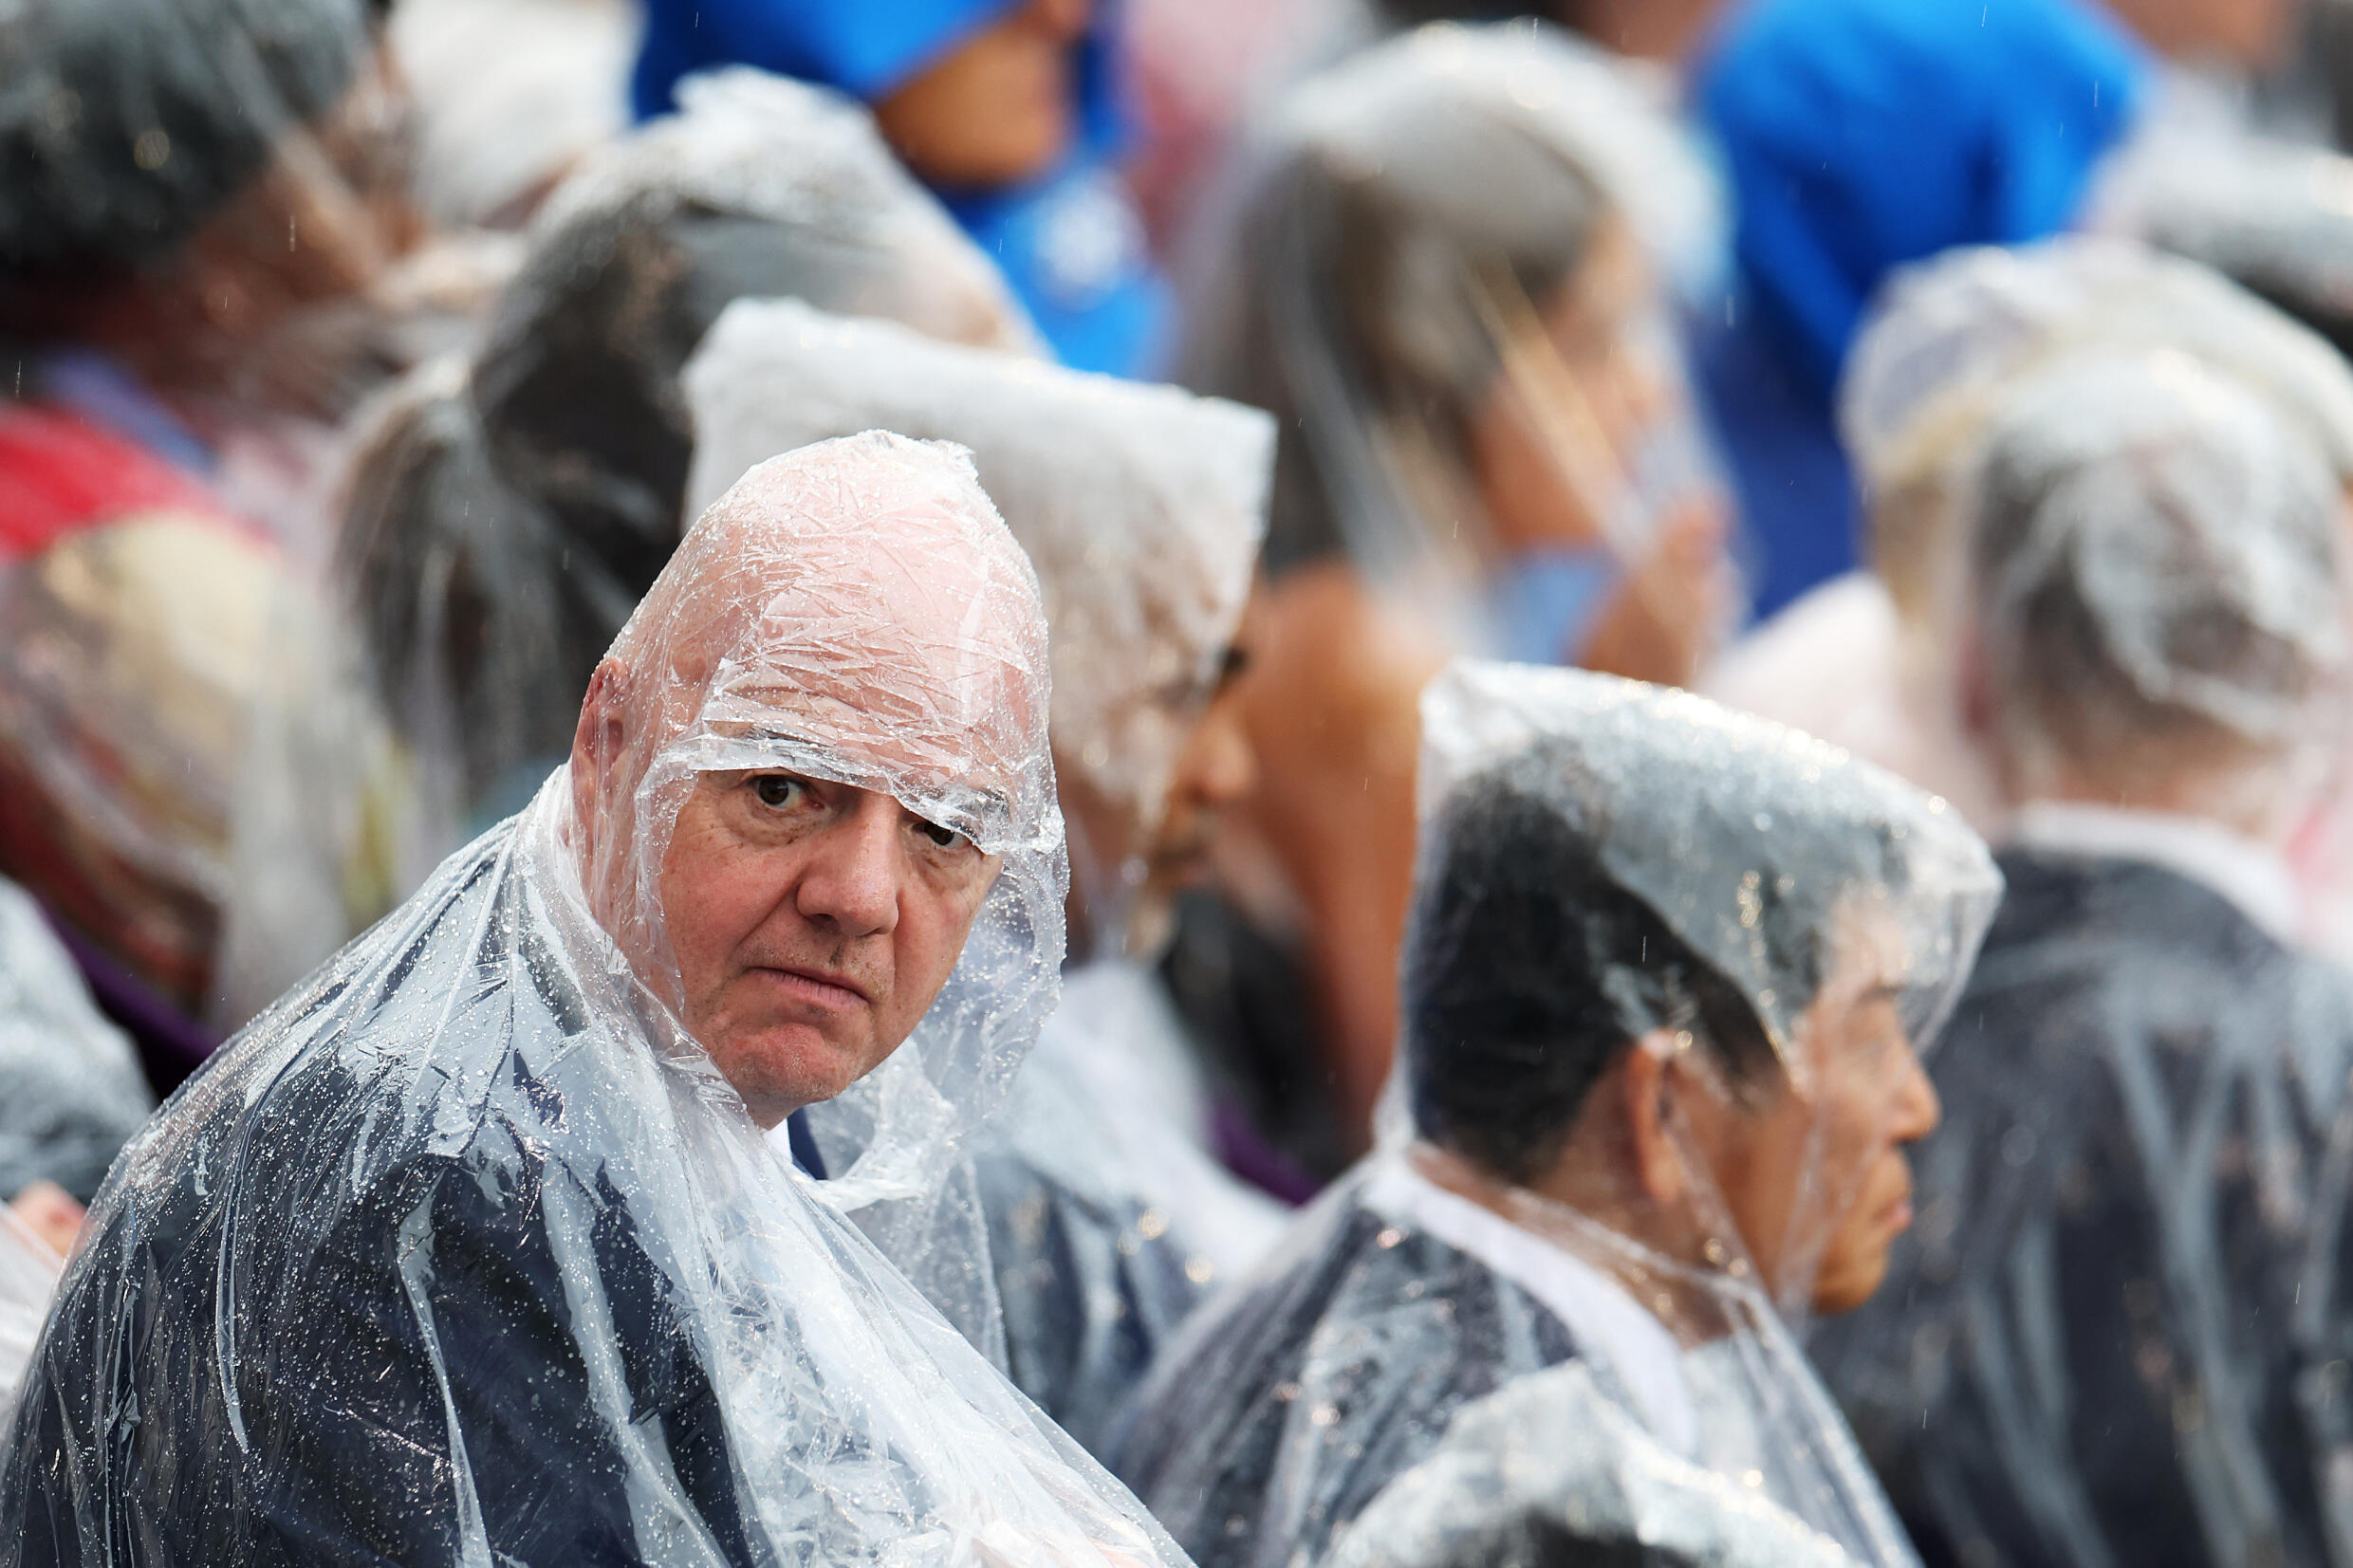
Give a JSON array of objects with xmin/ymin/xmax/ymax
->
[{"xmin": 1405, "ymin": 663, "xmax": 2000, "ymax": 1309}]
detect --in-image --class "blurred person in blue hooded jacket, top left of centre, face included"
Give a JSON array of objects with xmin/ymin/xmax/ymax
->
[{"xmin": 631, "ymin": 0, "xmax": 1170, "ymax": 377}]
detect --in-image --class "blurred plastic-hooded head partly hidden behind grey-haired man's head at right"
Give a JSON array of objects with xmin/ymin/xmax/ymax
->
[{"xmin": 1840, "ymin": 237, "xmax": 2353, "ymax": 658}]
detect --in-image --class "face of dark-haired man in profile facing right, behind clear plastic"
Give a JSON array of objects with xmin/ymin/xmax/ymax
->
[{"xmin": 1713, "ymin": 912, "xmax": 1941, "ymax": 1314}]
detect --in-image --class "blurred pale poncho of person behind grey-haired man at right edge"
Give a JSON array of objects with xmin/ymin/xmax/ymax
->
[{"xmin": 1708, "ymin": 237, "xmax": 2353, "ymax": 832}]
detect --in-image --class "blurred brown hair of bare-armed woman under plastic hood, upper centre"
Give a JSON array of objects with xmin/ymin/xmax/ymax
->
[{"xmin": 1183, "ymin": 65, "xmax": 1609, "ymax": 574}]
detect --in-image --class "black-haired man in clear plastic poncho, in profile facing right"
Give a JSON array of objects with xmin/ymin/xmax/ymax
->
[{"xmin": 1113, "ymin": 665, "xmax": 2000, "ymax": 1566}]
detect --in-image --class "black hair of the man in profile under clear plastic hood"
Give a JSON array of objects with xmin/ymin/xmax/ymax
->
[{"xmin": 1402, "ymin": 747, "xmax": 1771, "ymax": 1183}]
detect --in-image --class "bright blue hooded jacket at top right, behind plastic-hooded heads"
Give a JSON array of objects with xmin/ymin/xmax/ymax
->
[{"xmin": 1696, "ymin": 0, "xmax": 2151, "ymax": 614}]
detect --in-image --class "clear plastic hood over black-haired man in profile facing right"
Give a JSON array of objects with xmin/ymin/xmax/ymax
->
[{"xmin": 1421, "ymin": 660, "xmax": 2000, "ymax": 1083}]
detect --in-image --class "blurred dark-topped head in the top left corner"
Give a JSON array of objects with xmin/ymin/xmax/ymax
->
[{"xmin": 0, "ymin": 0, "xmax": 414, "ymax": 339}]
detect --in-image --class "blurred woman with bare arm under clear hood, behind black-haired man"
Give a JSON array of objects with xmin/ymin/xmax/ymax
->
[{"xmin": 1172, "ymin": 26, "xmax": 1736, "ymax": 1178}]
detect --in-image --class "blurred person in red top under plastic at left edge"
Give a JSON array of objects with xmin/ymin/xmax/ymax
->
[{"xmin": 0, "ymin": 0, "xmax": 444, "ymax": 1088}]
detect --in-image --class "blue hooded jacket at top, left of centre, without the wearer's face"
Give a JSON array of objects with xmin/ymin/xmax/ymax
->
[{"xmin": 631, "ymin": 0, "xmax": 1170, "ymax": 377}]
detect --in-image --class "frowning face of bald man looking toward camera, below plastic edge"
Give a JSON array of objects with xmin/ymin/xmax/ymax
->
[{"xmin": 661, "ymin": 773, "xmax": 998, "ymax": 1126}]
